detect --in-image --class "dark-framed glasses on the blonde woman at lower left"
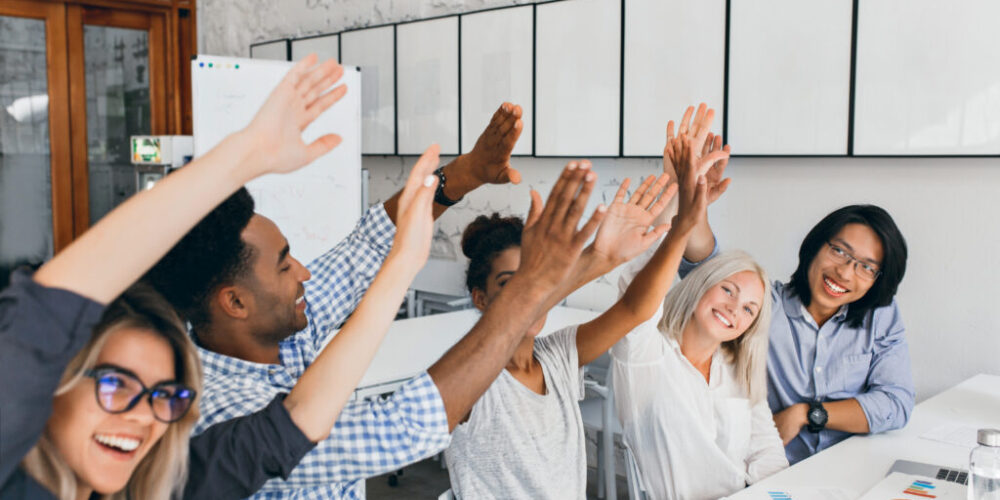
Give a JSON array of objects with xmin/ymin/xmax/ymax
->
[{"xmin": 84, "ymin": 365, "xmax": 196, "ymax": 423}]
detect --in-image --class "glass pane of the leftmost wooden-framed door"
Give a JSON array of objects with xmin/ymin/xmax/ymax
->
[{"xmin": 0, "ymin": 15, "xmax": 54, "ymax": 285}]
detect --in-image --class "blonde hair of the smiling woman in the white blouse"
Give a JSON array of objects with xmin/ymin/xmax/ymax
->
[{"xmin": 659, "ymin": 250, "xmax": 771, "ymax": 403}]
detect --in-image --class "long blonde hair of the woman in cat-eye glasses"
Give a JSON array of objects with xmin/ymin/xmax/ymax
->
[{"xmin": 21, "ymin": 284, "xmax": 201, "ymax": 500}]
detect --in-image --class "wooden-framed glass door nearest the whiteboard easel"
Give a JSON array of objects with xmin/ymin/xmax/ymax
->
[{"xmin": 67, "ymin": 5, "xmax": 170, "ymax": 230}]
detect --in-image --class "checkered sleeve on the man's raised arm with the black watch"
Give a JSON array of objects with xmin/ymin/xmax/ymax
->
[{"xmin": 305, "ymin": 203, "xmax": 396, "ymax": 349}]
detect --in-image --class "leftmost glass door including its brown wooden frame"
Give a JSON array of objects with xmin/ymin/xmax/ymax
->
[{"xmin": 0, "ymin": 0, "xmax": 73, "ymax": 286}]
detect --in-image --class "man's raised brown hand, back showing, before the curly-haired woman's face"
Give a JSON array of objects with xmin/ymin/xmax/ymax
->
[{"xmin": 512, "ymin": 160, "xmax": 607, "ymax": 291}]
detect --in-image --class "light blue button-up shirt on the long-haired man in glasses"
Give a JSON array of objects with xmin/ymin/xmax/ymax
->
[{"xmin": 680, "ymin": 240, "xmax": 915, "ymax": 464}]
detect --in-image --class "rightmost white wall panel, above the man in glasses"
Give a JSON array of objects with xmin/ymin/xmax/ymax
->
[{"xmin": 854, "ymin": 0, "xmax": 1000, "ymax": 155}]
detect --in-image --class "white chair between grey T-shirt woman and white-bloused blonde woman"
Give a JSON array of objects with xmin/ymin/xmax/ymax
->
[{"xmin": 580, "ymin": 354, "xmax": 621, "ymax": 499}]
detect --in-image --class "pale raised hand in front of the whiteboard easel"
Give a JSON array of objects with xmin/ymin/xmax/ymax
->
[{"xmin": 241, "ymin": 54, "xmax": 347, "ymax": 174}]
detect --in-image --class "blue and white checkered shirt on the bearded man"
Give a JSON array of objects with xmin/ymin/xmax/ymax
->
[{"xmin": 195, "ymin": 204, "xmax": 450, "ymax": 500}]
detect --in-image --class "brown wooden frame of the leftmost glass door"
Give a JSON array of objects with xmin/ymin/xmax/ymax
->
[{"xmin": 0, "ymin": 0, "xmax": 75, "ymax": 252}]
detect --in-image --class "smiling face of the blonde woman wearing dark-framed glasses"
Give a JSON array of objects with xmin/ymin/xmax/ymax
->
[{"xmin": 47, "ymin": 327, "xmax": 175, "ymax": 494}]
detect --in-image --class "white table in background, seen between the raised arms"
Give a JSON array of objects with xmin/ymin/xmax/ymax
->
[{"xmin": 344, "ymin": 306, "xmax": 598, "ymax": 399}]
